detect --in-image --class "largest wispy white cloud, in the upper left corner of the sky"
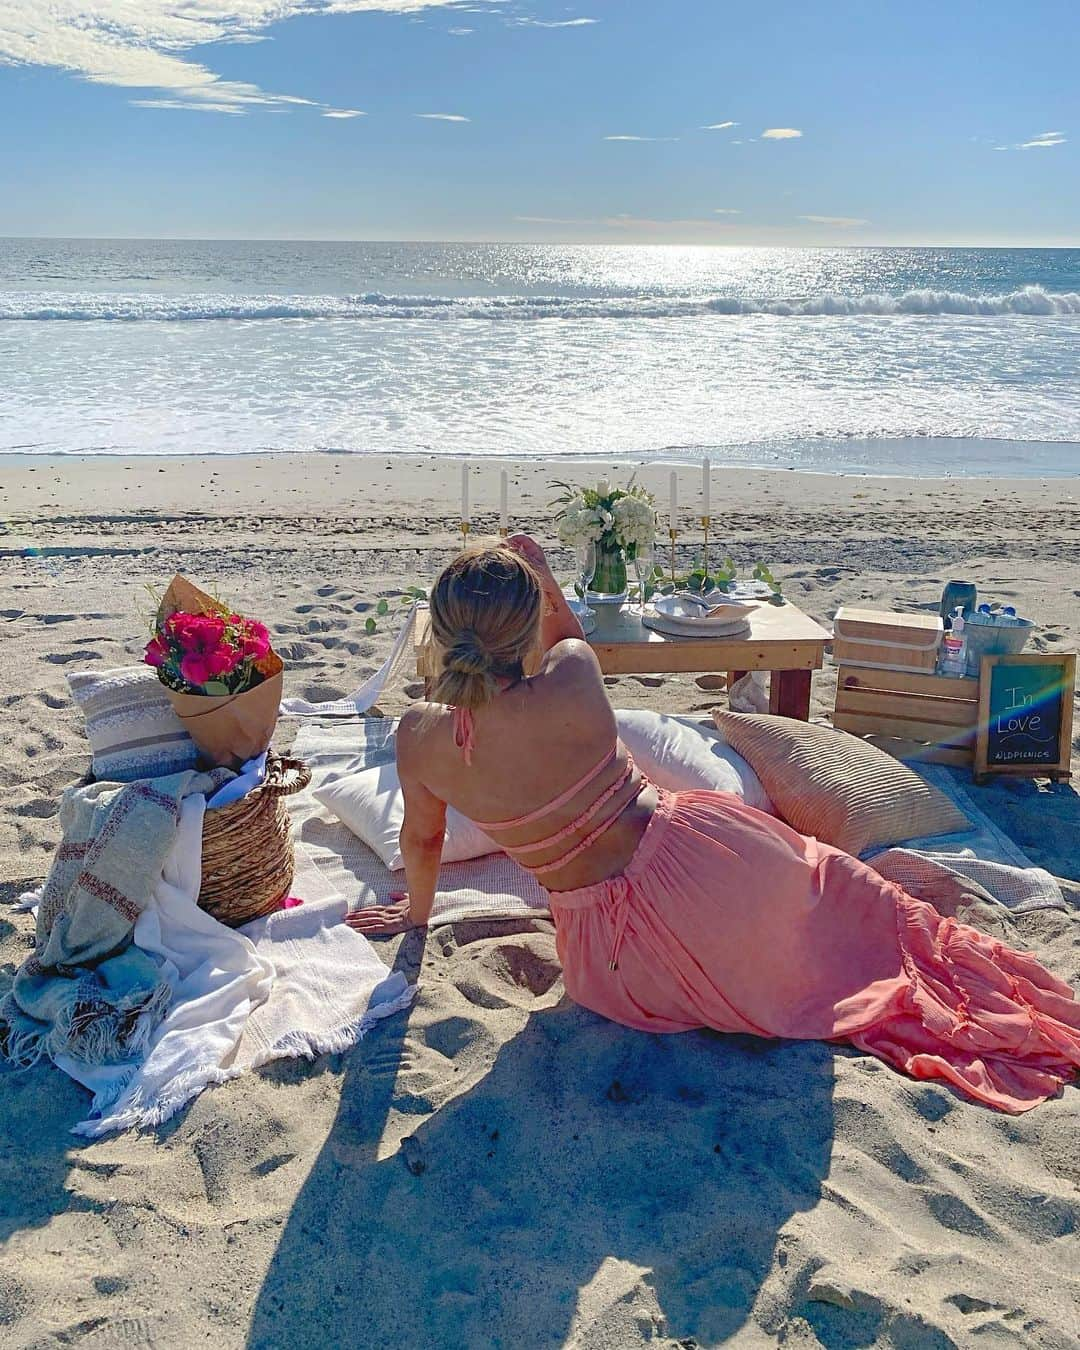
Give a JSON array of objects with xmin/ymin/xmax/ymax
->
[{"xmin": 0, "ymin": 0, "xmax": 480, "ymax": 113}]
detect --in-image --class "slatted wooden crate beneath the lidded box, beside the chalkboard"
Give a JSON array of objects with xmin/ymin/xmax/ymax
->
[{"xmin": 833, "ymin": 666, "xmax": 979, "ymax": 764}]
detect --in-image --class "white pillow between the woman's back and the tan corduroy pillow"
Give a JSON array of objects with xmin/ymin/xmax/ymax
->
[{"xmin": 616, "ymin": 709, "xmax": 776, "ymax": 815}]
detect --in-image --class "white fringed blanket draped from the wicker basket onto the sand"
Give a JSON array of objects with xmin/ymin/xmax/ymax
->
[{"xmin": 55, "ymin": 797, "xmax": 416, "ymax": 1138}]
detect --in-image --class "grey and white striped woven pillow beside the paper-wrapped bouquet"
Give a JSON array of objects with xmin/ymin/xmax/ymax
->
[{"xmin": 68, "ymin": 666, "xmax": 198, "ymax": 783}]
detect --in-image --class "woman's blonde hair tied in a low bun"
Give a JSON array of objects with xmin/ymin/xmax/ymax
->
[{"xmin": 428, "ymin": 544, "xmax": 543, "ymax": 709}]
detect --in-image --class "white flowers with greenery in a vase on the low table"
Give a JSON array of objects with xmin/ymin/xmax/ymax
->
[{"xmin": 554, "ymin": 478, "xmax": 656, "ymax": 595}]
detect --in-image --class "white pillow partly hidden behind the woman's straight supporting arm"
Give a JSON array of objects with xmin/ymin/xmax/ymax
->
[{"xmin": 315, "ymin": 764, "xmax": 500, "ymax": 872}]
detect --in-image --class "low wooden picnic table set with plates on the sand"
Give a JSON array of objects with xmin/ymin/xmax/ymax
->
[{"xmin": 416, "ymin": 601, "xmax": 832, "ymax": 722}]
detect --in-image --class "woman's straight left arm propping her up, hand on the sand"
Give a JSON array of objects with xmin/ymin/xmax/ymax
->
[{"xmin": 346, "ymin": 714, "xmax": 447, "ymax": 936}]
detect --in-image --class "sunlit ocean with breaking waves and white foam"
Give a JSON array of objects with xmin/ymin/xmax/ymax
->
[{"xmin": 0, "ymin": 239, "xmax": 1080, "ymax": 477}]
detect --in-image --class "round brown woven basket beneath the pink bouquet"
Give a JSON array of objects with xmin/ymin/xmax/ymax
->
[{"xmin": 198, "ymin": 753, "xmax": 312, "ymax": 927}]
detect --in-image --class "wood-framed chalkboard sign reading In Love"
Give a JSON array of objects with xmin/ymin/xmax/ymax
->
[{"xmin": 975, "ymin": 655, "xmax": 1076, "ymax": 782}]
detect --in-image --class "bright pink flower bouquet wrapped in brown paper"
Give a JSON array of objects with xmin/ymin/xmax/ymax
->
[{"xmin": 143, "ymin": 575, "xmax": 284, "ymax": 768}]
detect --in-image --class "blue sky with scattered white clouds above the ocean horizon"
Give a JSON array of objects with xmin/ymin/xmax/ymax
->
[{"xmin": 0, "ymin": 0, "xmax": 1080, "ymax": 246}]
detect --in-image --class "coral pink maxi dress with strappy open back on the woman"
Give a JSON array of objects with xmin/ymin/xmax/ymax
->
[{"xmin": 455, "ymin": 716, "xmax": 1080, "ymax": 1114}]
